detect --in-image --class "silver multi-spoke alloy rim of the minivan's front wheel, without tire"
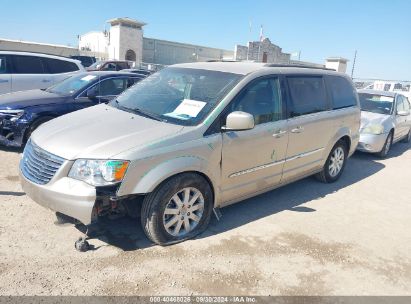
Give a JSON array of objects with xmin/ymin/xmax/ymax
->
[{"xmin": 163, "ymin": 187, "xmax": 204, "ymax": 237}]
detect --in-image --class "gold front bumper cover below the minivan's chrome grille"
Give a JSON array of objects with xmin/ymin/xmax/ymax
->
[{"xmin": 20, "ymin": 170, "xmax": 96, "ymax": 225}]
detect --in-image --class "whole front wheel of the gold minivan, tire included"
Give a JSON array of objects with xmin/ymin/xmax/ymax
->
[{"xmin": 141, "ymin": 173, "xmax": 213, "ymax": 246}]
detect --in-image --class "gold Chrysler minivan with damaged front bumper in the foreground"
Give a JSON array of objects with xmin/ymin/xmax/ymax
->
[{"xmin": 20, "ymin": 62, "xmax": 360, "ymax": 250}]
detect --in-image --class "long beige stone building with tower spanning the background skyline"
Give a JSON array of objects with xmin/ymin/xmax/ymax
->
[{"xmin": 0, "ymin": 18, "xmax": 348, "ymax": 73}]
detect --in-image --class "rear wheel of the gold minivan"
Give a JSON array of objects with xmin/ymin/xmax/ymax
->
[{"xmin": 316, "ymin": 140, "xmax": 347, "ymax": 183}]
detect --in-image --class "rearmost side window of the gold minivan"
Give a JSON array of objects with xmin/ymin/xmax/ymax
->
[{"xmin": 327, "ymin": 76, "xmax": 357, "ymax": 109}]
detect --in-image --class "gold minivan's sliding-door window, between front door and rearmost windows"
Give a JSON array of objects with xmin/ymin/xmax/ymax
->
[{"xmin": 287, "ymin": 76, "xmax": 328, "ymax": 117}]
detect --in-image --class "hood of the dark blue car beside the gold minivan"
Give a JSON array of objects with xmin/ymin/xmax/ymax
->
[{"xmin": 0, "ymin": 90, "xmax": 67, "ymax": 110}]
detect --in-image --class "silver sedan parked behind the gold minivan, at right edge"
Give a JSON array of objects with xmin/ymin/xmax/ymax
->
[{"xmin": 357, "ymin": 90, "xmax": 411, "ymax": 157}]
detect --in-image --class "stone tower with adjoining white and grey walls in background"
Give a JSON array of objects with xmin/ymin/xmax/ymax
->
[{"xmin": 79, "ymin": 18, "xmax": 234, "ymax": 65}]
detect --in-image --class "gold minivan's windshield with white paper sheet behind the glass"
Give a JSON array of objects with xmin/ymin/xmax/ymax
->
[{"xmin": 114, "ymin": 67, "xmax": 242, "ymax": 126}]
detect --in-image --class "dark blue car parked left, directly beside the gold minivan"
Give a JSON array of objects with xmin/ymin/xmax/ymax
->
[{"xmin": 0, "ymin": 72, "xmax": 143, "ymax": 147}]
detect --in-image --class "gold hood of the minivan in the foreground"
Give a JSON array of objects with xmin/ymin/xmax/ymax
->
[{"xmin": 31, "ymin": 105, "xmax": 183, "ymax": 160}]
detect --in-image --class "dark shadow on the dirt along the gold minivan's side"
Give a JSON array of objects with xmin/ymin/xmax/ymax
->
[{"xmin": 199, "ymin": 146, "xmax": 392, "ymax": 238}]
